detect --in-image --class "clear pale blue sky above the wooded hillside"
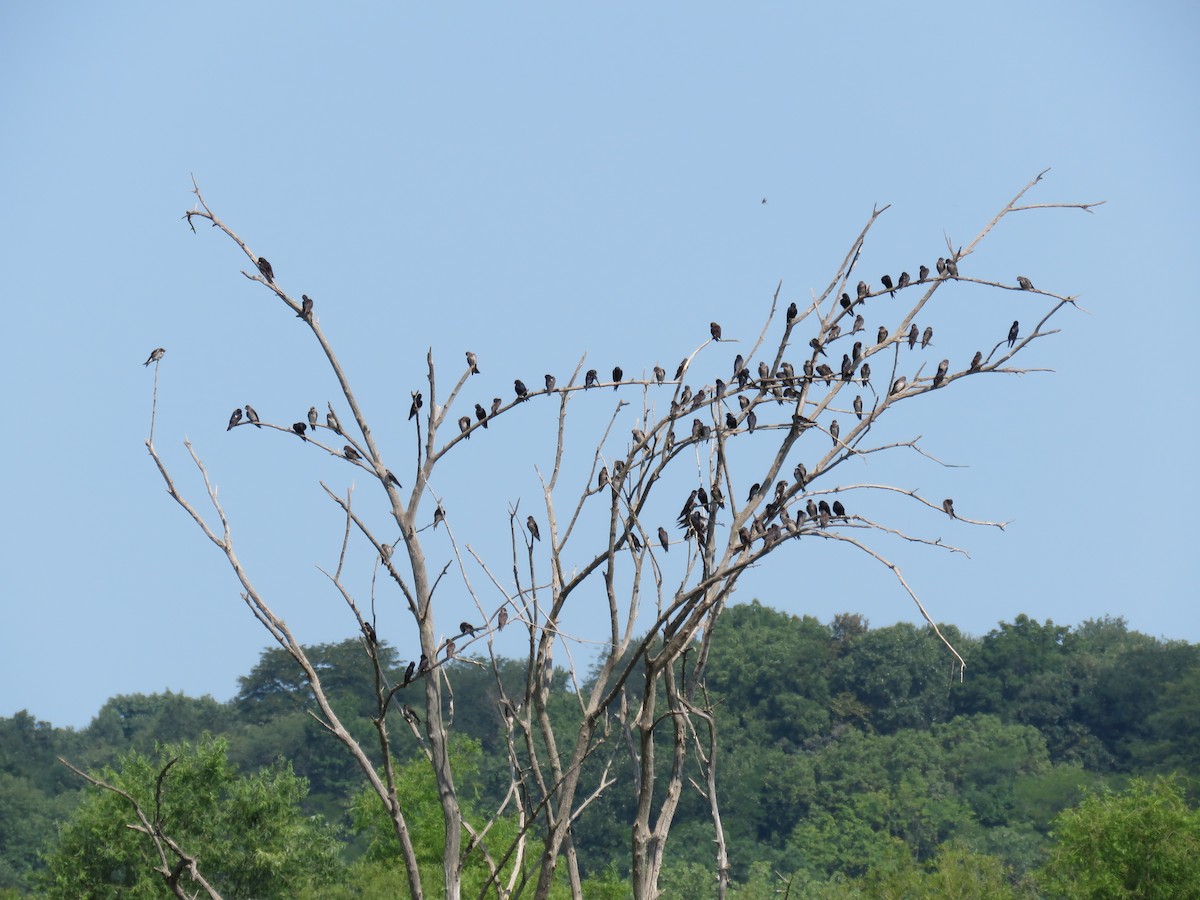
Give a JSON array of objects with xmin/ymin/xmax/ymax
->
[{"xmin": 0, "ymin": 1, "xmax": 1200, "ymax": 727}]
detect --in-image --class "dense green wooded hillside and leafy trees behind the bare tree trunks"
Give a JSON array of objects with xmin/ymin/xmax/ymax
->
[{"xmin": 0, "ymin": 604, "xmax": 1200, "ymax": 899}]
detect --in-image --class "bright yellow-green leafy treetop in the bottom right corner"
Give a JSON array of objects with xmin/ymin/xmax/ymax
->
[{"xmin": 1039, "ymin": 779, "xmax": 1200, "ymax": 900}]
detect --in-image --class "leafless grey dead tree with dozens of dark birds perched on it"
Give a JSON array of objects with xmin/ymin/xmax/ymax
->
[{"xmin": 133, "ymin": 173, "xmax": 1098, "ymax": 898}]
